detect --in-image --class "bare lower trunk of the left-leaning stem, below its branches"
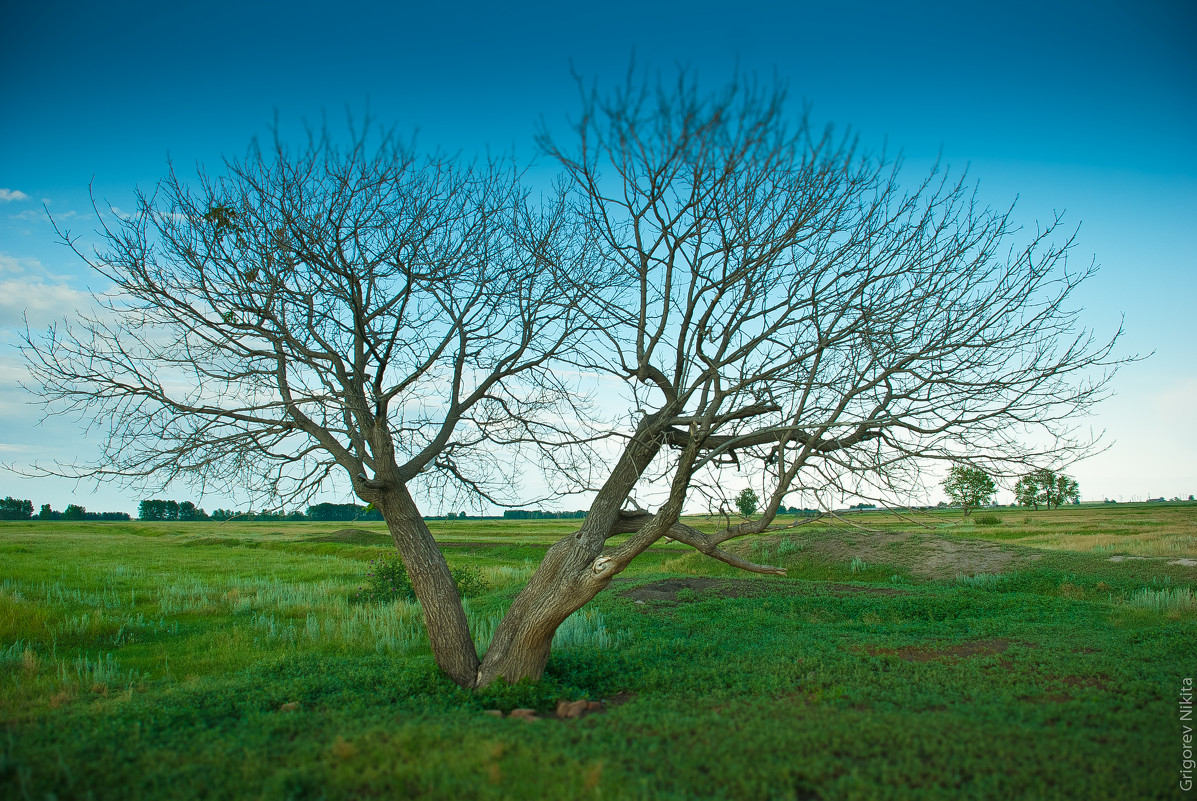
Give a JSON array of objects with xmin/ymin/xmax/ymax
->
[{"xmin": 373, "ymin": 486, "xmax": 479, "ymax": 687}]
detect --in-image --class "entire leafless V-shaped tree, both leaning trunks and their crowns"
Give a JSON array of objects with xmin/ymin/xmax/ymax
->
[{"xmin": 26, "ymin": 74, "xmax": 1113, "ymax": 686}]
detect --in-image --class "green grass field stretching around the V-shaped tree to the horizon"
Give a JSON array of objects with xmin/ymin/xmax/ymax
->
[{"xmin": 0, "ymin": 503, "xmax": 1197, "ymax": 801}]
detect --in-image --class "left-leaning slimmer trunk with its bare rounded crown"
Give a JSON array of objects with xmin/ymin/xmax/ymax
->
[{"xmin": 24, "ymin": 125, "xmax": 598, "ymax": 686}]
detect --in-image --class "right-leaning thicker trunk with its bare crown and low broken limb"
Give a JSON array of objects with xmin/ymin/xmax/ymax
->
[{"xmin": 469, "ymin": 73, "xmax": 1117, "ymax": 682}]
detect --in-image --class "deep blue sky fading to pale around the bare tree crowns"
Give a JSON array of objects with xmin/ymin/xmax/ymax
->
[{"xmin": 0, "ymin": 0, "xmax": 1197, "ymax": 511}]
